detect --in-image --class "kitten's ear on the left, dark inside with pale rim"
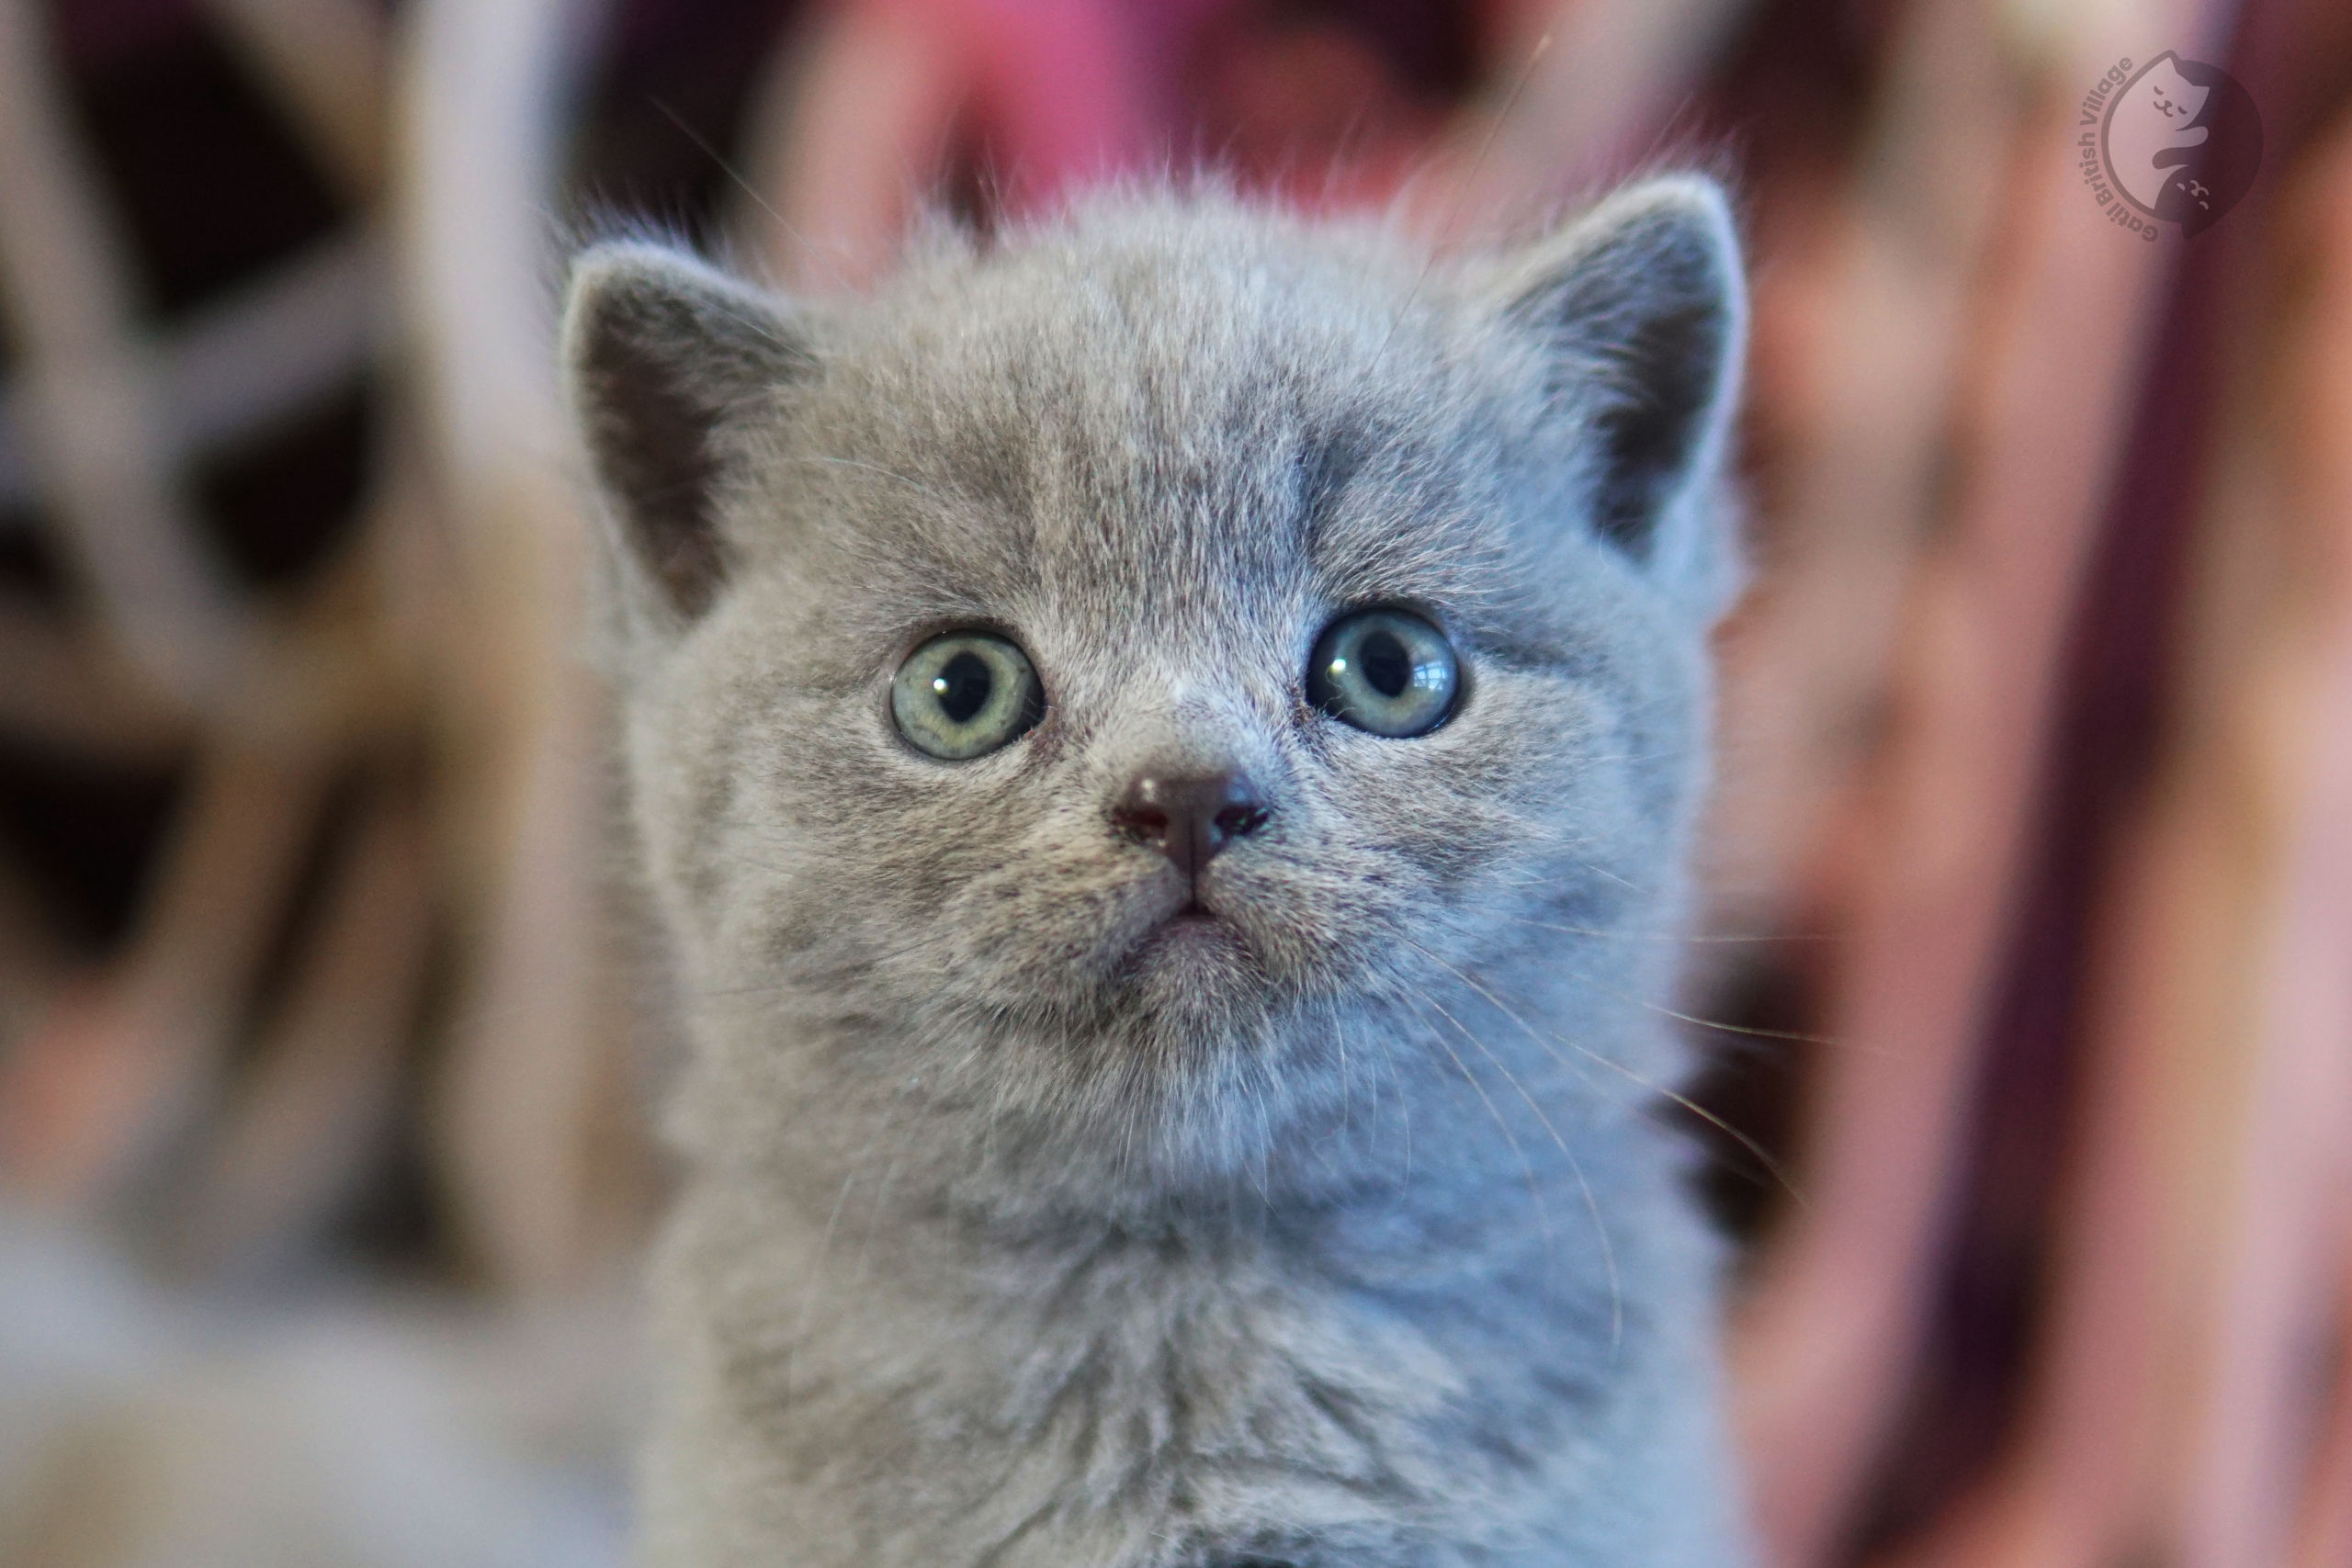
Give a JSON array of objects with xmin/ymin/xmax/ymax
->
[{"xmin": 562, "ymin": 243, "xmax": 814, "ymax": 627}]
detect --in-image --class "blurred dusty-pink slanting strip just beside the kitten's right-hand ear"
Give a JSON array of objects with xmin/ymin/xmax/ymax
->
[{"xmin": 1705, "ymin": 0, "xmax": 2028, "ymax": 931}]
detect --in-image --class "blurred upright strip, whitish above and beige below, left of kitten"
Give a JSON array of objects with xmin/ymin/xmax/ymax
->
[{"xmin": 395, "ymin": 0, "xmax": 635, "ymax": 1295}]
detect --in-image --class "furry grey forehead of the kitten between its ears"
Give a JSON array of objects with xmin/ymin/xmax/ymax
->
[{"xmin": 802, "ymin": 211, "xmax": 1491, "ymax": 644}]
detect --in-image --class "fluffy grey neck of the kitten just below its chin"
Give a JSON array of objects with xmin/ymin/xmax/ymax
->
[{"xmin": 677, "ymin": 992, "xmax": 1665, "ymax": 1248}]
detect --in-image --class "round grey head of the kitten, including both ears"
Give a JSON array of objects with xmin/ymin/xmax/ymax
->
[{"xmin": 564, "ymin": 179, "xmax": 1746, "ymax": 1189}]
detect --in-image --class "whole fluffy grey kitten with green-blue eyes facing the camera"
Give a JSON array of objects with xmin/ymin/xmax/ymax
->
[{"xmin": 562, "ymin": 179, "xmax": 1746, "ymax": 1568}]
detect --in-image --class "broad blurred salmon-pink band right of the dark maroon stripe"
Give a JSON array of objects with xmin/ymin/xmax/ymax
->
[{"xmin": 1871, "ymin": 73, "xmax": 2352, "ymax": 1568}]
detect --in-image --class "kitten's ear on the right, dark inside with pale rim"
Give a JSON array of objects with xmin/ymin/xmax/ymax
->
[{"xmin": 1505, "ymin": 174, "xmax": 1747, "ymax": 594}]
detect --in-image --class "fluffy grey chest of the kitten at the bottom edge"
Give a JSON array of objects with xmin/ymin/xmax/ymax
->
[{"xmin": 695, "ymin": 1194, "xmax": 1636, "ymax": 1563}]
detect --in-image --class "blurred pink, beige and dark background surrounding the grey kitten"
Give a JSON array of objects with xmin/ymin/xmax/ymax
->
[{"xmin": 0, "ymin": 0, "xmax": 2352, "ymax": 1568}]
